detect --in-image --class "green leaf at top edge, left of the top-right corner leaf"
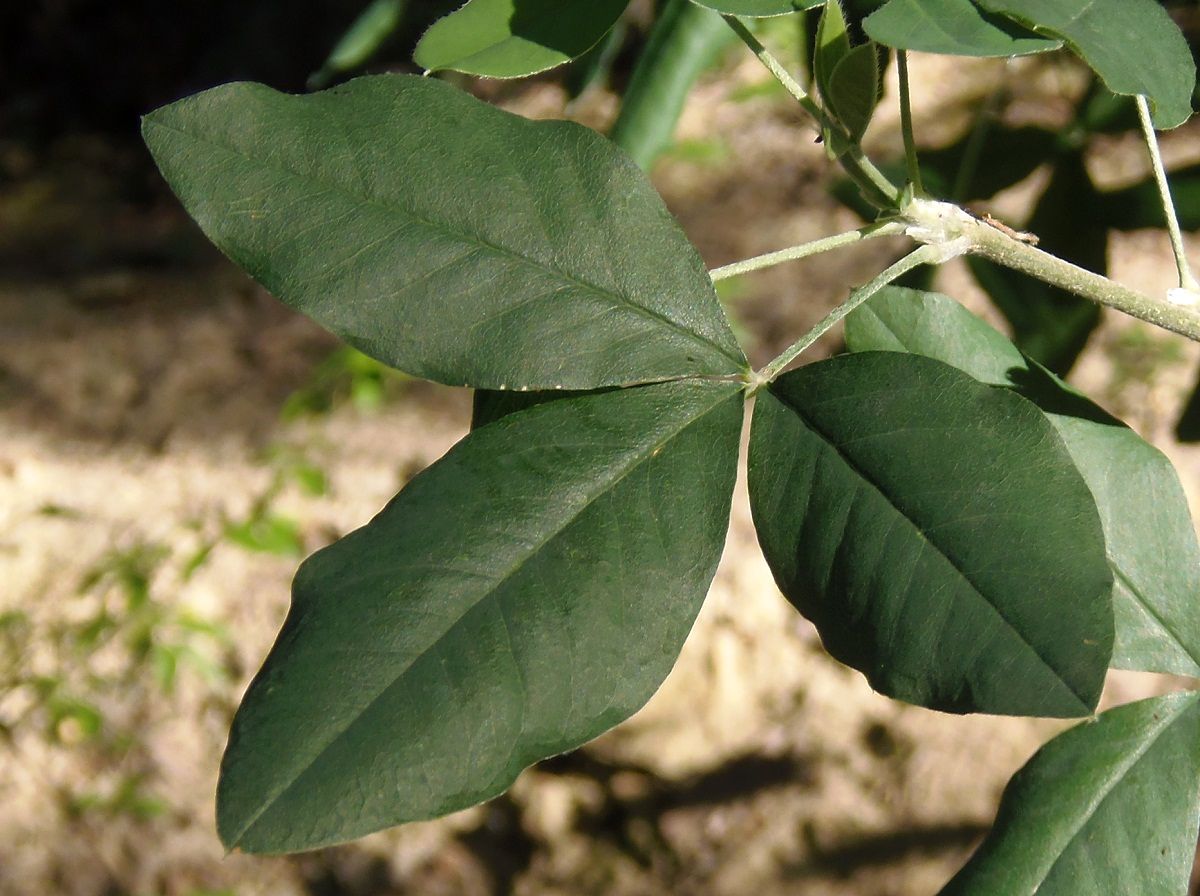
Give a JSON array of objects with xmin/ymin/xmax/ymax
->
[{"xmin": 863, "ymin": 0, "xmax": 1062, "ymax": 56}]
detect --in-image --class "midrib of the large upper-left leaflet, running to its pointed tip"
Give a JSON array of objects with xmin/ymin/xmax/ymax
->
[{"xmin": 145, "ymin": 114, "xmax": 744, "ymax": 373}]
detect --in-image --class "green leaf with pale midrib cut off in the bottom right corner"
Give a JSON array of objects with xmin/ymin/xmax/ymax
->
[{"xmin": 941, "ymin": 693, "xmax": 1200, "ymax": 896}]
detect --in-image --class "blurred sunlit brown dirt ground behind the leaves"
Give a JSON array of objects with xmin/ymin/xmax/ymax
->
[{"xmin": 0, "ymin": 50, "xmax": 1200, "ymax": 896}]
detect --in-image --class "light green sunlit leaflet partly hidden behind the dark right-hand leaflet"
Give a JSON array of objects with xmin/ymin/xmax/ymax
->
[{"xmin": 846, "ymin": 288, "xmax": 1200, "ymax": 675}]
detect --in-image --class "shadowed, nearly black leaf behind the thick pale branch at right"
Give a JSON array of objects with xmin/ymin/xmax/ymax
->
[{"xmin": 967, "ymin": 152, "xmax": 1108, "ymax": 374}]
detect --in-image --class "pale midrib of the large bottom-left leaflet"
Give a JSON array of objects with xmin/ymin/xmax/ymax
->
[{"xmin": 220, "ymin": 393, "xmax": 736, "ymax": 848}]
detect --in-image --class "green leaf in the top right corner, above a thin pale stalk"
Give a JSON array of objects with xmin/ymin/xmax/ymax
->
[{"xmin": 974, "ymin": 0, "xmax": 1196, "ymax": 128}]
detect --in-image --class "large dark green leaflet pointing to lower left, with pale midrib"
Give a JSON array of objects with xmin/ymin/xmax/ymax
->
[{"xmin": 217, "ymin": 381, "xmax": 742, "ymax": 852}]
